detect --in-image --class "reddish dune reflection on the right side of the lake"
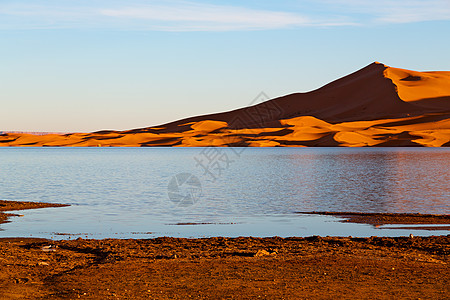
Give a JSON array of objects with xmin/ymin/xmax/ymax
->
[{"xmin": 251, "ymin": 148, "xmax": 450, "ymax": 213}]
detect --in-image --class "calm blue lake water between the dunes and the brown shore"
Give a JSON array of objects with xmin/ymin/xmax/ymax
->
[{"xmin": 0, "ymin": 148, "xmax": 450, "ymax": 238}]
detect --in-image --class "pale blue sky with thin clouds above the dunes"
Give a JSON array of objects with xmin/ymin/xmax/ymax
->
[{"xmin": 0, "ymin": 0, "xmax": 450, "ymax": 132}]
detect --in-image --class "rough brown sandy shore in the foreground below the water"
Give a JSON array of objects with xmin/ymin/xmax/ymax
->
[{"xmin": 0, "ymin": 202, "xmax": 450, "ymax": 299}]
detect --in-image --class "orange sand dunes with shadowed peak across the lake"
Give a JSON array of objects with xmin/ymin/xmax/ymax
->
[{"xmin": 0, "ymin": 62, "xmax": 450, "ymax": 147}]
